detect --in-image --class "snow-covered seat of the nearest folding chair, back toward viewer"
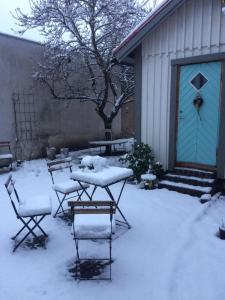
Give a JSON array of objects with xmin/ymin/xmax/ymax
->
[{"xmin": 74, "ymin": 214, "xmax": 115, "ymax": 239}]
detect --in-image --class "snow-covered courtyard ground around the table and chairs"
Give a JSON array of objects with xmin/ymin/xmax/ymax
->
[{"xmin": 0, "ymin": 158, "xmax": 225, "ymax": 300}]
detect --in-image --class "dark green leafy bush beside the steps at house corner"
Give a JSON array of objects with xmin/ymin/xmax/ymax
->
[{"xmin": 123, "ymin": 143, "xmax": 164, "ymax": 182}]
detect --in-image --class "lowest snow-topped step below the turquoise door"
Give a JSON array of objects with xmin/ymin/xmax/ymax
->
[{"xmin": 158, "ymin": 180, "xmax": 212, "ymax": 197}]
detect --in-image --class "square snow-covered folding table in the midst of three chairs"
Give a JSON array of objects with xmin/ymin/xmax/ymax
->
[{"xmin": 70, "ymin": 167, "xmax": 133, "ymax": 228}]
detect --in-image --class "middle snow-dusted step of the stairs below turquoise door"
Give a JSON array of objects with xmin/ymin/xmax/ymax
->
[{"xmin": 164, "ymin": 173, "xmax": 215, "ymax": 187}]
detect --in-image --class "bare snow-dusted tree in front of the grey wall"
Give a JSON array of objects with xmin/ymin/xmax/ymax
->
[{"xmin": 15, "ymin": 0, "xmax": 146, "ymax": 154}]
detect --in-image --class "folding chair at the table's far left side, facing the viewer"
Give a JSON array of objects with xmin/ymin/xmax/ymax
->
[{"xmin": 47, "ymin": 157, "xmax": 89, "ymax": 217}]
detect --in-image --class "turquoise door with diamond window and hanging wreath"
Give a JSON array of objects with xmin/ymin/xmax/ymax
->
[{"xmin": 177, "ymin": 62, "xmax": 221, "ymax": 166}]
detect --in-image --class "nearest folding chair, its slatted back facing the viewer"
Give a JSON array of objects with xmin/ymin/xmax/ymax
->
[{"xmin": 68, "ymin": 201, "xmax": 116, "ymax": 280}]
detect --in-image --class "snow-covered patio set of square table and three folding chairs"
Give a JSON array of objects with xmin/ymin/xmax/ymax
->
[{"xmin": 5, "ymin": 157, "xmax": 133, "ymax": 280}]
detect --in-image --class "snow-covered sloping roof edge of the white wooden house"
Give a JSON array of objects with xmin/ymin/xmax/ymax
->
[{"xmin": 114, "ymin": 0, "xmax": 173, "ymax": 54}]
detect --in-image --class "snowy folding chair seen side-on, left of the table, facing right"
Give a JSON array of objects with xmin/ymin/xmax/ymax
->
[{"xmin": 5, "ymin": 175, "xmax": 51, "ymax": 252}]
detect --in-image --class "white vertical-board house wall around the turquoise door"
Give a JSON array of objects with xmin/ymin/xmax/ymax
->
[{"xmin": 141, "ymin": 0, "xmax": 225, "ymax": 168}]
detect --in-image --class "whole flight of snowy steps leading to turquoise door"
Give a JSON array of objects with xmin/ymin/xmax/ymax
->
[{"xmin": 159, "ymin": 167, "xmax": 215, "ymax": 197}]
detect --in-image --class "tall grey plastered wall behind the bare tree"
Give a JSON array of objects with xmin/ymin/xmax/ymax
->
[{"xmin": 0, "ymin": 34, "xmax": 121, "ymax": 159}]
